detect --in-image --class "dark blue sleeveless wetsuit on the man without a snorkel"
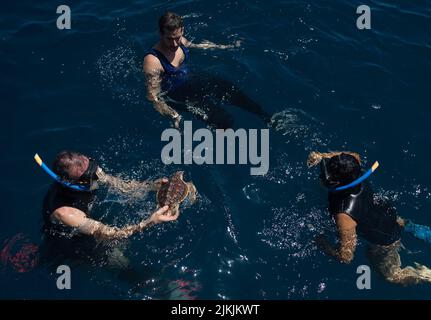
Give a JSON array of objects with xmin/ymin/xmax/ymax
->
[{"xmin": 147, "ymin": 45, "xmax": 270, "ymax": 129}]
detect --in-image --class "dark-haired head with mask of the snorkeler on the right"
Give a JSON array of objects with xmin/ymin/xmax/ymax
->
[{"xmin": 320, "ymin": 153, "xmax": 361, "ymax": 188}]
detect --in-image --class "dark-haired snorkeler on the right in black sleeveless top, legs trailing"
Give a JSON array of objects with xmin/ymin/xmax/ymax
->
[{"xmin": 307, "ymin": 152, "xmax": 431, "ymax": 285}]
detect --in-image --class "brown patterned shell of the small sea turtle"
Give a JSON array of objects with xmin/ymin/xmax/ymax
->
[{"xmin": 157, "ymin": 171, "xmax": 189, "ymax": 208}]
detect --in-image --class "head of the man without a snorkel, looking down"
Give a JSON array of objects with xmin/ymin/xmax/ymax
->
[{"xmin": 159, "ymin": 12, "xmax": 184, "ymax": 52}]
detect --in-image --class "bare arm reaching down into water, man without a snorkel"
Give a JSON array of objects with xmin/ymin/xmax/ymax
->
[{"xmin": 143, "ymin": 54, "xmax": 181, "ymax": 128}]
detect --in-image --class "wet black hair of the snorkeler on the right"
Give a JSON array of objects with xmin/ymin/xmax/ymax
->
[{"xmin": 327, "ymin": 153, "xmax": 361, "ymax": 185}]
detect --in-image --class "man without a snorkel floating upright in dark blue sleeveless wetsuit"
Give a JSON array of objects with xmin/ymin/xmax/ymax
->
[{"xmin": 143, "ymin": 12, "xmax": 270, "ymax": 129}]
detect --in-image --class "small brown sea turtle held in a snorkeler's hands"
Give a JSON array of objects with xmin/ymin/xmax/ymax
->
[{"xmin": 156, "ymin": 171, "xmax": 196, "ymax": 215}]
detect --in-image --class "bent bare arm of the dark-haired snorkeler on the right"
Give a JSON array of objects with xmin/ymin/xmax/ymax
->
[{"xmin": 317, "ymin": 213, "xmax": 356, "ymax": 263}]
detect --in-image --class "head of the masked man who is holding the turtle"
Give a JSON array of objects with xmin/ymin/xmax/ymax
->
[{"xmin": 53, "ymin": 151, "xmax": 99, "ymax": 187}]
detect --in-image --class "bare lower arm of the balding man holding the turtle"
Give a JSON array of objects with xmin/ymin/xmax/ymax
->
[{"xmin": 52, "ymin": 206, "xmax": 179, "ymax": 240}]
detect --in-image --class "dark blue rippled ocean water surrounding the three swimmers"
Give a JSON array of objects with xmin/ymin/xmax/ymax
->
[{"xmin": 0, "ymin": 0, "xmax": 431, "ymax": 299}]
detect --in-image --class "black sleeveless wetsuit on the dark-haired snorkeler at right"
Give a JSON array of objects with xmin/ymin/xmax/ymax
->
[{"xmin": 328, "ymin": 183, "xmax": 401, "ymax": 246}]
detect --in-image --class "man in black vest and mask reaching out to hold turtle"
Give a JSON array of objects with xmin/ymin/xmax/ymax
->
[{"xmin": 43, "ymin": 151, "xmax": 178, "ymax": 264}]
